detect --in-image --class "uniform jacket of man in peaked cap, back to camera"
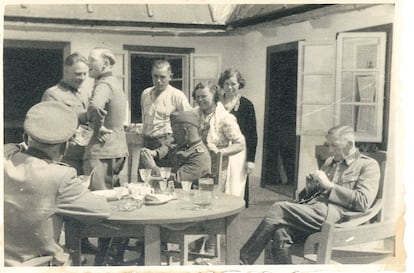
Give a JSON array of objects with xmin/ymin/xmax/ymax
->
[{"xmin": 4, "ymin": 144, "xmax": 110, "ymax": 262}]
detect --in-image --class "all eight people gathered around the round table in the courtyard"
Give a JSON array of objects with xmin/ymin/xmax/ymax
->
[{"xmin": 4, "ymin": 48, "xmax": 380, "ymax": 265}]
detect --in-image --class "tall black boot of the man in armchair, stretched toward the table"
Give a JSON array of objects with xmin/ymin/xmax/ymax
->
[{"xmin": 240, "ymin": 220, "xmax": 275, "ymax": 264}]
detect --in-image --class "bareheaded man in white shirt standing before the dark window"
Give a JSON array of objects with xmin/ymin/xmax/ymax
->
[{"xmin": 141, "ymin": 60, "xmax": 192, "ymax": 166}]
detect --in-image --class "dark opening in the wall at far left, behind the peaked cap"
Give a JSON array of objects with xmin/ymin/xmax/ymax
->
[{"xmin": 3, "ymin": 44, "xmax": 64, "ymax": 143}]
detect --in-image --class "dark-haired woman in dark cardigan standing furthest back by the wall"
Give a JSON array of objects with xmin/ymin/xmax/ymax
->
[{"xmin": 218, "ymin": 68, "xmax": 257, "ymax": 208}]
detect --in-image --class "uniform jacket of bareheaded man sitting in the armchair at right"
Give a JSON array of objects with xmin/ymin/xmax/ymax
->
[{"xmin": 300, "ymin": 151, "xmax": 381, "ymax": 223}]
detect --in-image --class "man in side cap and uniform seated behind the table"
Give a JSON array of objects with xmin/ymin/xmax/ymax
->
[{"xmin": 140, "ymin": 111, "xmax": 211, "ymax": 183}]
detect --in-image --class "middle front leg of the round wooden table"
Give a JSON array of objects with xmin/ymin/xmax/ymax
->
[{"xmin": 144, "ymin": 225, "xmax": 161, "ymax": 265}]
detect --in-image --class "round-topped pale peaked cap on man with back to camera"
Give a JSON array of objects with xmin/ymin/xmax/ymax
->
[{"xmin": 23, "ymin": 101, "xmax": 78, "ymax": 144}]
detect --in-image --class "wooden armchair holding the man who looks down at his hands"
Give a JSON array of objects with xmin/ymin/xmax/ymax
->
[{"xmin": 265, "ymin": 146, "xmax": 395, "ymax": 264}]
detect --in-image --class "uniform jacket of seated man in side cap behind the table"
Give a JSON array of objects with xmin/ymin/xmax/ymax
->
[{"xmin": 157, "ymin": 140, "xmax": 211, "ymax": 183}]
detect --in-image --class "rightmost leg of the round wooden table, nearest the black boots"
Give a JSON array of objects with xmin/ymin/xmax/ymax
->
[{"xmin": 226, "ymin": 214, "xmax": 240, "ymax": 265}]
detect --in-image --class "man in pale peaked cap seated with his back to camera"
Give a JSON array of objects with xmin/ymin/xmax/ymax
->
[{"xmin": 4, "ymin": 101, "xmax": 110, "ymax": 265}]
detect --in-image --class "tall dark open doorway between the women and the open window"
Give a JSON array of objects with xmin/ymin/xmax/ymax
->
[{"xmin": 261, "ymin": 42, "xmax": 299, "ymax": 197}]
